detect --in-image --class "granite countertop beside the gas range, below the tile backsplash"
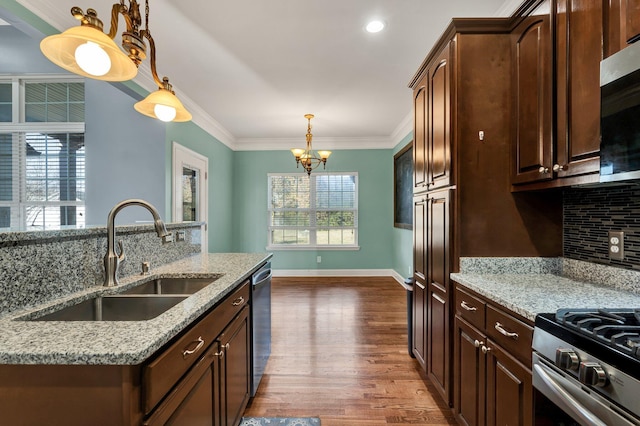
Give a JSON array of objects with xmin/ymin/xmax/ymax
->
[{"xmin": 451, "ymin": 273, "xmax": 640, "ymax": 322}]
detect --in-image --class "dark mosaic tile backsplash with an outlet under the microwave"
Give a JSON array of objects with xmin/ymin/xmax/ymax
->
[{"xmin": 563, "ymin": 182, "xmax": 640, "ymax": 270}]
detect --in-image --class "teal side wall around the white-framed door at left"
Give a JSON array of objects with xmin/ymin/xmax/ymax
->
[{"xmin": 165, "ymin": 122, "xmax": 235, "ymax": 253}]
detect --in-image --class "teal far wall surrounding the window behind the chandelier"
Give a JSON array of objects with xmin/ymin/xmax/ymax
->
[{"xmin": 233, "ymin": 149, "xmax": 394, "ymax": 270}]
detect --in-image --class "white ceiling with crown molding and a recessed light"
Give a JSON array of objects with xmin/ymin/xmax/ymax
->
[{"xmin": 18, "ymin": 0, "xmax": 520, "ymax": 150}]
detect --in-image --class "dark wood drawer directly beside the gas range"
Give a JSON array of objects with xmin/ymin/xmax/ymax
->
[{"xmin": 487, "ymin": 305, "xmax": 533, "ymax": 368}]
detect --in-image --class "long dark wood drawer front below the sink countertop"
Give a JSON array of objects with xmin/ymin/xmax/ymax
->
[{"xmin": 142, "ymin": 281, "xmax": 250, "ymax": 415}]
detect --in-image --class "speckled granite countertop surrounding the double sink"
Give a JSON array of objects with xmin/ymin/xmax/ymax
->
[{"xmin": 0, "ymin": 253, "xmax": 271, "ymax": 365}]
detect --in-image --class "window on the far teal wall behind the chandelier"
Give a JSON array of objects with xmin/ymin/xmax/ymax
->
[{"xmin": 268, "ymin": 173, "xmax": 358, "ymax": 249}]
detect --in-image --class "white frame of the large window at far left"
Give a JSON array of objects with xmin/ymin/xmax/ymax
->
[{"xmin": 0, "ymin": 74, "xmax": 86, "ymax": 230}]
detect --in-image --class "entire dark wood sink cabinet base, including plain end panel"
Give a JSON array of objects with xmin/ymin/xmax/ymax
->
[{"xmin": 0, "ymin": 281, "xmax": 251, "ymax": 426}]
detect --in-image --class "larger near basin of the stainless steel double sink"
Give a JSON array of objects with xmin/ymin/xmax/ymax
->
[{"xmin": 32, "ymin": 295, "xmax": 187, "ymax": 321}]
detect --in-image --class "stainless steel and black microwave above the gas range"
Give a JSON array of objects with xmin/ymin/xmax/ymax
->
[{"xmin": 600, "ymin": 42, "xmax": 640, "ymax": 182}]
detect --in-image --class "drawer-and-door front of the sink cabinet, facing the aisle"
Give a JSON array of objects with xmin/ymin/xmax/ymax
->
[{"xmin": 148, "ymin": 284, "xmax": 251, "ymax": 426}]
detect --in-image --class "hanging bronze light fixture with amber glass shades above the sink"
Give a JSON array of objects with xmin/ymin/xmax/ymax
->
[{"xmin": 40, "ymin": 0, "xmax": 191, "ymax": 122}]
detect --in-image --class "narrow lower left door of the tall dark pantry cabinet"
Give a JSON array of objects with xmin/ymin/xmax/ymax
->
[{"xmin": 412, "ymin": 195, "xmax": 427, "ymax": 366}]
